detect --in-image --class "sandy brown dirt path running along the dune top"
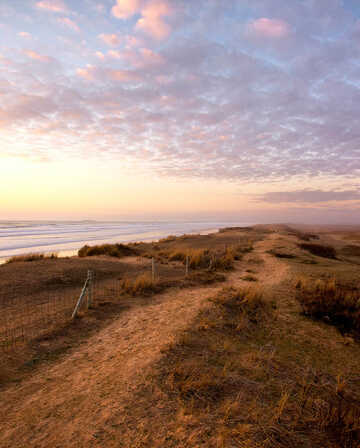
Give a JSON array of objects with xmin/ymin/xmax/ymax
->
[{"xmin": 0, "ymin": 235, "xmax": 287, "ymax": 448}]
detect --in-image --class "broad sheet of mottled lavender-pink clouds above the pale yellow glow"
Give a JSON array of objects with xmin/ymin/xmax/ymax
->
[{"xmin": 0, "ymin": 0, "xmax": 360, "ymax": 221}]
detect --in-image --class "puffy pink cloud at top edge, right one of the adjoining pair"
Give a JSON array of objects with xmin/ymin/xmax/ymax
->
[{"xmin": 136, "ymin": 0, "xmax": 173, "ymax": 39}]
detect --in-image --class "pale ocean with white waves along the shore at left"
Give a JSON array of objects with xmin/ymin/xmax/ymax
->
[{"xmin": 0, "ymin": 221, "xmax": 251, "ymax": 263}]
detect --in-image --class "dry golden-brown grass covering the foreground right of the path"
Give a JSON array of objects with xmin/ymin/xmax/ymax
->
[{"xmin": 146, "ymin": 282, "xmax": 360, "ymax": 448}]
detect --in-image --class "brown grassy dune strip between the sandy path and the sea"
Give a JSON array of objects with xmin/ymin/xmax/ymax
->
[{"xmin": 0, "ymin": 226, "xmax": 260, "ymax": 376}]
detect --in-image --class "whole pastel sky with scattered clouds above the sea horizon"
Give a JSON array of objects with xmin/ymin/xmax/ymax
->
[{"xmin": 0, "ymin": 0, "xmax": 360, "ymax": 223}]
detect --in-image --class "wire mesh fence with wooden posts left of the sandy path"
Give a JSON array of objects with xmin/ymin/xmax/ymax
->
[{"xmin": 0, "ymin": 258, "xmax": 188, "ymax": 351}]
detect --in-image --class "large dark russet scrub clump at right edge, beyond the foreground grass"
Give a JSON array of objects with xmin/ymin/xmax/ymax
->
[{"xmin": 296, "ymin": 278, "xmax": 360, "ymax": 336}]
